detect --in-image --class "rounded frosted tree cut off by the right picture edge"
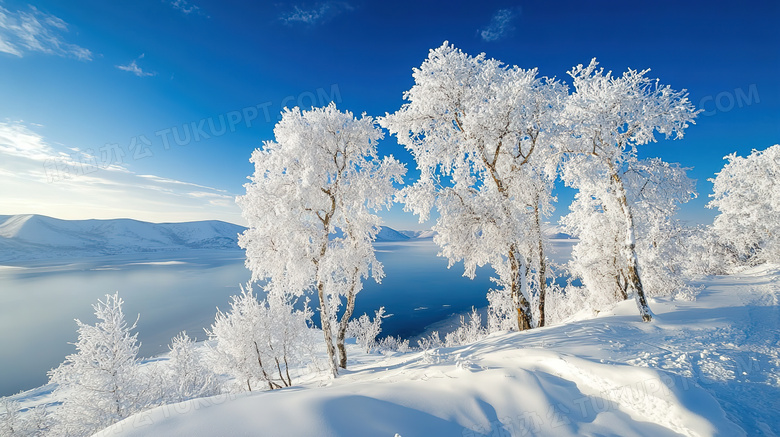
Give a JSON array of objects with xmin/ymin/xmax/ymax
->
[{"xmin": 707, "ymin": 145, "xmax": 780, "ymax": 264}]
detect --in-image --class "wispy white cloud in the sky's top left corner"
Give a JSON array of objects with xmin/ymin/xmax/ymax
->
[{"xmin": 0, "ymin": 6, "xmax": 92, "ymax": 61}]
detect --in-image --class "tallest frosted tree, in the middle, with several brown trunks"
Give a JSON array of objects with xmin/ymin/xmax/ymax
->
[{"xmin": 380, "ymin": 42, "xmax": 566, "ymax": 330}]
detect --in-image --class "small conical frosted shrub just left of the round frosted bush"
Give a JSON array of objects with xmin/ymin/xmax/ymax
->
[{"xmin": 166, "ymin": 331, "xmax": 220, "ymax": 402}]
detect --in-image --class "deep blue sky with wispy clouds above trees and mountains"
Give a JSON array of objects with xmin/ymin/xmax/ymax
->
[{"xmin": 0, "ymin": 0, "xmax": 780, "ymax": 229}]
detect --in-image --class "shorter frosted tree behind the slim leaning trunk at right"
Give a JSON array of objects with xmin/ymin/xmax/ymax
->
[{"xmin": 561, "ymin": 156, "xmax": 695, "ymax": 309}]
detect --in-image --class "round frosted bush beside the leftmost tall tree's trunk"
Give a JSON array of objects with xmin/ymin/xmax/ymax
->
[{"xmin": 206, "ymin": 284, "xmax": 313, "ymax": 391}]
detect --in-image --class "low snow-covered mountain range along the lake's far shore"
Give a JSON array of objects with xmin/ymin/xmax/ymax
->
[{"xmin": 0, "ymin": 214, "xmax": 425, "ymax": 261}]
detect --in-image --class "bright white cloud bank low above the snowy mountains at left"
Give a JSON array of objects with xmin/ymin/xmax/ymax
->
[{"xmin": 0, "ymin": 121, "xmax": 243, "ymax": 224}]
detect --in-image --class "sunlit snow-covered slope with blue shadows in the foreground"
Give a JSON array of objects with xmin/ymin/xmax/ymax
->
[{"xmin": 47, "ymin": 260, "xmax": 780, "ymax": 437}]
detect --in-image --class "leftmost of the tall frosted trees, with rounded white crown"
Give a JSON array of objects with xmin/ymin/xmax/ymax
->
[{"xmin": 237, "ymin": 104, "xmax": 406, "ymax": 375}]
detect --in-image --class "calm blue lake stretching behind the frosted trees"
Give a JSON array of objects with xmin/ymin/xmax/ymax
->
[{"xmin": 0, "ymin": 240, "xmax": 570, "ymax": 396}]
